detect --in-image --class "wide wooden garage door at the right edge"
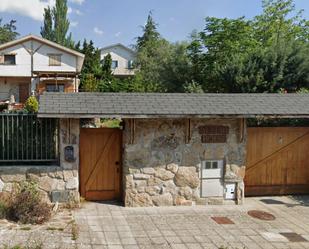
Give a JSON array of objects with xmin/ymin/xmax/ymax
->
[{"xmin": 245, "ymin": 127, "xmax": 309, "ymax": 196}]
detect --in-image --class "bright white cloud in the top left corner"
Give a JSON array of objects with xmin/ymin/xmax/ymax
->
[{"xmin": 0, "ymin": 0, "xmax": 55, "ymax": 21}]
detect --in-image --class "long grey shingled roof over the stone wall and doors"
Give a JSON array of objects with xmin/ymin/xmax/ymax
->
[{"xmin": 39, "ymin": 93, "xmax": 309, "ymax": 118}]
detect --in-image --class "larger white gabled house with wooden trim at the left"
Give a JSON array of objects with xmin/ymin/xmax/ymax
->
[{"xmin": 0, "ymin": 35, "xmax": 84, "ymax": 103}]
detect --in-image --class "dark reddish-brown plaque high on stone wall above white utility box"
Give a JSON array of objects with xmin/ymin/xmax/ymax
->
[{"xmin": 198, "ymin": 125, "xmax": 229, "ymax": 143}]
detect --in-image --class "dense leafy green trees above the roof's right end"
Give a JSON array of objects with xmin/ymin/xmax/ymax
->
[{"xmin": 188, "ymin": 0, "xmax": 309, "ymax": 92}]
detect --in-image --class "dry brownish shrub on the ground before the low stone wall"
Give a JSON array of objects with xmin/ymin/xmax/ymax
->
[{"xmin": 8, "ymin": 181, "xmax": 51, "ymax": 224}]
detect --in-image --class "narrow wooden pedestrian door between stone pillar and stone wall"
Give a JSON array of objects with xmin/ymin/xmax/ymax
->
[{"xmin": 80, "ymin": 128, "xmax": 122, "ymax": 201}]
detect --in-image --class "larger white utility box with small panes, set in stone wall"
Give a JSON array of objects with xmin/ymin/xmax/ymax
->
[{"xmin": 201, "ymin": 160, "xmax": 223, "ymax": 197}]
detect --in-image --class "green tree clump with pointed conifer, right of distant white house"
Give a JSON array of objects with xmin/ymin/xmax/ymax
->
[{"xmin": 135, "ymin": 13, "xmax": 191, "ymax": 92}]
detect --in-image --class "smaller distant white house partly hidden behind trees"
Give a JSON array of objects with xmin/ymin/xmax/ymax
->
[{"xmin": 100, "ymin": 43, "xmax": 136, "ymax": 77}]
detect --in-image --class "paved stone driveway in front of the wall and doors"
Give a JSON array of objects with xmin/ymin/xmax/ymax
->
[{"xmin": 74, "ymin": 196, "xmax": 309, "ymax": 249}]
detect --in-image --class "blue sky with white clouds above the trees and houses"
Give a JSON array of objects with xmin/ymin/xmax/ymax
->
[{"xmin": 0, "ymin": 0, "xmax": 309, "ymax": 47}]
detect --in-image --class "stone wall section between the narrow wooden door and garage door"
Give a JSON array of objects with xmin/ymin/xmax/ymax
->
[{"xmin": 123, "ymin": 119, "xmax": 246, "ymax": 207}]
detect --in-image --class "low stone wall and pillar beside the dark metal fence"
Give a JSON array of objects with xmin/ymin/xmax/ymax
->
[{"xmin": 0, "ymin": 119, "xmax": 80, "ymax": 202}]
